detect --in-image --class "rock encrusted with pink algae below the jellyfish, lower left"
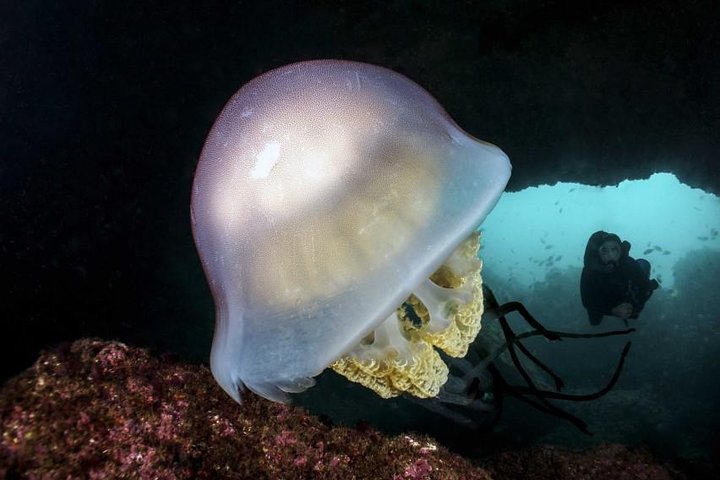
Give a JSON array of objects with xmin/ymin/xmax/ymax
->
[{"xmin": 0, "ymin": 340, "xmax": 490, "ymax": 480}]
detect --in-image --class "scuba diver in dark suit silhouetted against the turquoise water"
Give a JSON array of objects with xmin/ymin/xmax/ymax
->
[{"xmin": 580, "ymin": 230, "xmax": 659, "ymax": 325}]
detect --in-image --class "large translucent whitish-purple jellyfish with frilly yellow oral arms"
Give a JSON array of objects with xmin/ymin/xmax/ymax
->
[{"xmin": 191, "ymin": 60, "xmax": 510, "ymax": 401}]
